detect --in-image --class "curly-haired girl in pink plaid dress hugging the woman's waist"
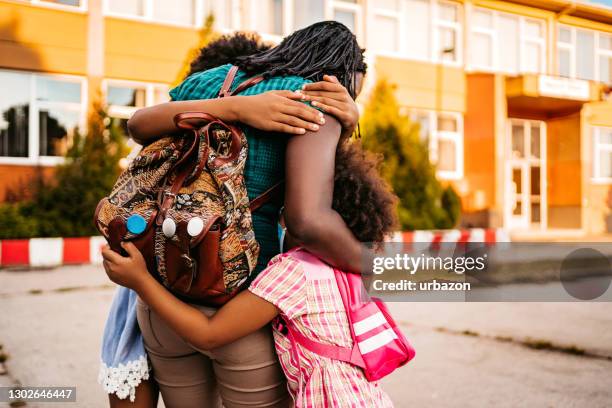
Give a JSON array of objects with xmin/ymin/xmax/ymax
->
[{"xmin": 103, "ymin": 141, "xmax": 397, "ymax": 407}]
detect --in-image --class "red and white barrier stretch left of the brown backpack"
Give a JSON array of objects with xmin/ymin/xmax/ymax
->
[{"xmin": 0, "ymin": 237, "xmax": 106, "ymax": 268}]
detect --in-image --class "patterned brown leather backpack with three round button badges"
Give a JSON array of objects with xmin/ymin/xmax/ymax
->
[{"xmin": 94, "ymin": 67, "xmax": 282, "ymax": 306}]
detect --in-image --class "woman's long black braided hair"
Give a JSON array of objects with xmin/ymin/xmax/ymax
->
[{"xmin": 236, "ymin": 21, "xmax": 367, "ymax": 99}]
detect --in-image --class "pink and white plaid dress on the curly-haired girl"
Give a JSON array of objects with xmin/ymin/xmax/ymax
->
[{"xmin": 249, "ymin": 250, "xmax": 393, "ymax": 408}]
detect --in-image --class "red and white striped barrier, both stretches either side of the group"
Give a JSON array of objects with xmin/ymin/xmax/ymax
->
[{"xmin": 0, "ymin": 228, "xmax": 510, "ymax": 268}]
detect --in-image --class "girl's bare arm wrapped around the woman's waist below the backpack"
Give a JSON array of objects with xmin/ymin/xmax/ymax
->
[{"xmin": 102, "ymin": 242, "xmax": 278, "ymax": 350}]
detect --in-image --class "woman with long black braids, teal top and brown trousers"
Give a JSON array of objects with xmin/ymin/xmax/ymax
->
[{"xmin": 105, "ymin": 21, "xmax": 367, "ymax": 408}]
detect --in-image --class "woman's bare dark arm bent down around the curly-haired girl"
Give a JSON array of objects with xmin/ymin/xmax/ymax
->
[{"xmin": 284, "ymin": 115, "xmax": 367, "ymax": 273}]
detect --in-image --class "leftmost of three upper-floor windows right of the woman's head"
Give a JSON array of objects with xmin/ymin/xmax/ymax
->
[{"xmin": 369, "ymin": 0, "xmax": 463, "ymax": 64}]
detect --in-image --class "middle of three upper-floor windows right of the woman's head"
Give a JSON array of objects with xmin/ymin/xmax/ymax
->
[{"xmin": 469, "ymin": 8, "xmax": 546, "ymax": 74}]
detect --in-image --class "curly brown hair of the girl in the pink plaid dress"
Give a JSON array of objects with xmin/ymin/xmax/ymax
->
[{"xmin": 332, "ymin": 140, "xmax": 398, "ymax": 243}]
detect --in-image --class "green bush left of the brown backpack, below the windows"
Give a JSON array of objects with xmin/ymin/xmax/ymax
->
[{"xmin": 0, "ymin": 101, "xmax": 127, "ymax": 238}]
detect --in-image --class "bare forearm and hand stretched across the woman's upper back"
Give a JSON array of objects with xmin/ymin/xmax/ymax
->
[{"xmin": 128, "ymin": 91, "xmax": 323, "ymax": 144}]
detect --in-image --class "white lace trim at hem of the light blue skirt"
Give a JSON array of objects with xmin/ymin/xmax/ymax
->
[{"xmin": 98, "ymin": 356, "xmax": 149, "ymax": 402}]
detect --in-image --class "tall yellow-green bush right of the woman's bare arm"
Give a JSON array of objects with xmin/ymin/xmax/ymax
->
[{"xmin": 361, "ymin": 80, "xmax": 461, "ymax": 230}]
